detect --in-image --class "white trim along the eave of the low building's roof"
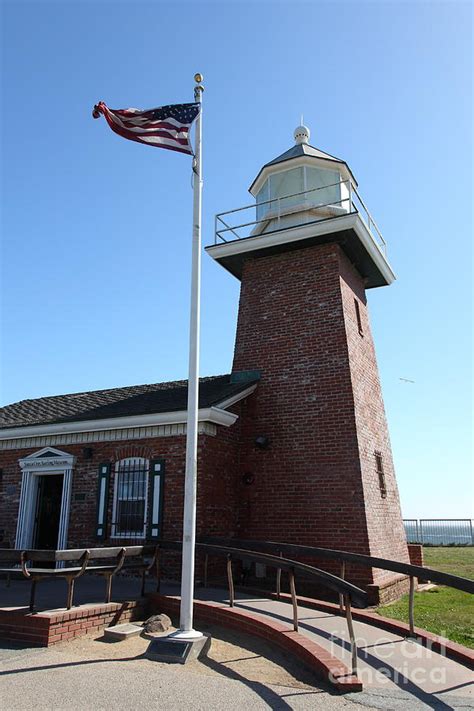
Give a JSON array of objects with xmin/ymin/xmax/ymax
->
[{"xmin": 0, "ymin": 406, "xmax": 237, "ymax": 440}]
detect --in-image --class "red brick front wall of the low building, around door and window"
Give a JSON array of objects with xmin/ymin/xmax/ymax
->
[{"xmin": 0, "ymin": 404, "xmax": 240, "ymax": 552}]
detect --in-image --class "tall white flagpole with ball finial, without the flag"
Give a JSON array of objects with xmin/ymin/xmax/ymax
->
[{"xmin": 173, "ymin": 74, "xmax": 204, "ymax": 639}]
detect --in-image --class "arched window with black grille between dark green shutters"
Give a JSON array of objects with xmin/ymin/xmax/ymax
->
[{"xmin": 111, "ymin": 457, "xmax": 149, "ymax": 538}]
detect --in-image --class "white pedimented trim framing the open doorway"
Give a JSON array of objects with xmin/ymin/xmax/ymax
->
[{"xmin": 15, "ymin": 447, "xmax": 76, "ymax": 549}]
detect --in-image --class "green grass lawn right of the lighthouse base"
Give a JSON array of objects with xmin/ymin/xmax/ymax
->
[{"xmin": 377, "ymin": 547, "xmax": 474, "ymax": 649}]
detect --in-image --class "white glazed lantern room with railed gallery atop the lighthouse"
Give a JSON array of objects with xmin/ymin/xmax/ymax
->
[{"xmin": 206, "ymin": 126, "xmax": 395, "ymax": 289}]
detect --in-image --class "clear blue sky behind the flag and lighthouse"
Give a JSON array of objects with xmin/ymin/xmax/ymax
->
[{"xmin": 1, "ymin": 0, "xmax": 472, "ymax": 517}]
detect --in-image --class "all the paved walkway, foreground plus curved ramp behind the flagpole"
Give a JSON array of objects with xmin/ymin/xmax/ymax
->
[{"xmin": 0, "ymin": 578, "xmax": 474, "ymax": 711}]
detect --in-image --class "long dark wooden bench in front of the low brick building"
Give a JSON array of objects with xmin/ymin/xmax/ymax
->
[{"xmin": 0, "ymin": 546, "xmax": 159, "ymax": 612}]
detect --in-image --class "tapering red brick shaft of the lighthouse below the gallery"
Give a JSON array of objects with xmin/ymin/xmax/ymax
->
[{"xmin": 233, "ymin": 244, "xmax": 408, "ymax": 583}]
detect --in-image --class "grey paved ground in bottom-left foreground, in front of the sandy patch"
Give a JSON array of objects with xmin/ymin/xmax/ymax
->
[{"xmin": 0, "ymin": 640, "xmax": 346, "ymax": 711}]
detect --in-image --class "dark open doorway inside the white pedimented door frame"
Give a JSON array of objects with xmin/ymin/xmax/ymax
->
[{"xmin": 33, "ymin": 474, "xmax": 64, "ymax": 550}]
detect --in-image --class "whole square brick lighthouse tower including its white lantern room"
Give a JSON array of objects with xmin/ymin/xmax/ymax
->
[{"xmin": 207, "ymin": 126, "xmax": 408, "ymax": 600}]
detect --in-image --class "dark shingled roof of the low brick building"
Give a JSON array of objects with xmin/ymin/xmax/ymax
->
[{"xmin": 0, "ymin": 375, "xmax": 256, "ymax": 430}]
